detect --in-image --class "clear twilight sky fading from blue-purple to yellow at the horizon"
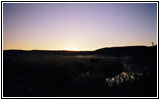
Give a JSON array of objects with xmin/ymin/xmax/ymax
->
[{"xmin": 3, "ymin": 3, "xmax": 157, "ymax": 50}]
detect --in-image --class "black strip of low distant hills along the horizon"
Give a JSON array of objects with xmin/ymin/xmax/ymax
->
[{"xmin": 3, "ymin": 45, "xmax": 157, "ymax": 56}]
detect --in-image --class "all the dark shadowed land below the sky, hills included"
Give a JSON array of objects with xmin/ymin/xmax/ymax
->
[{"xmin": 3, "ymin": 46, "xmax": 157, "ymax": 97}]
